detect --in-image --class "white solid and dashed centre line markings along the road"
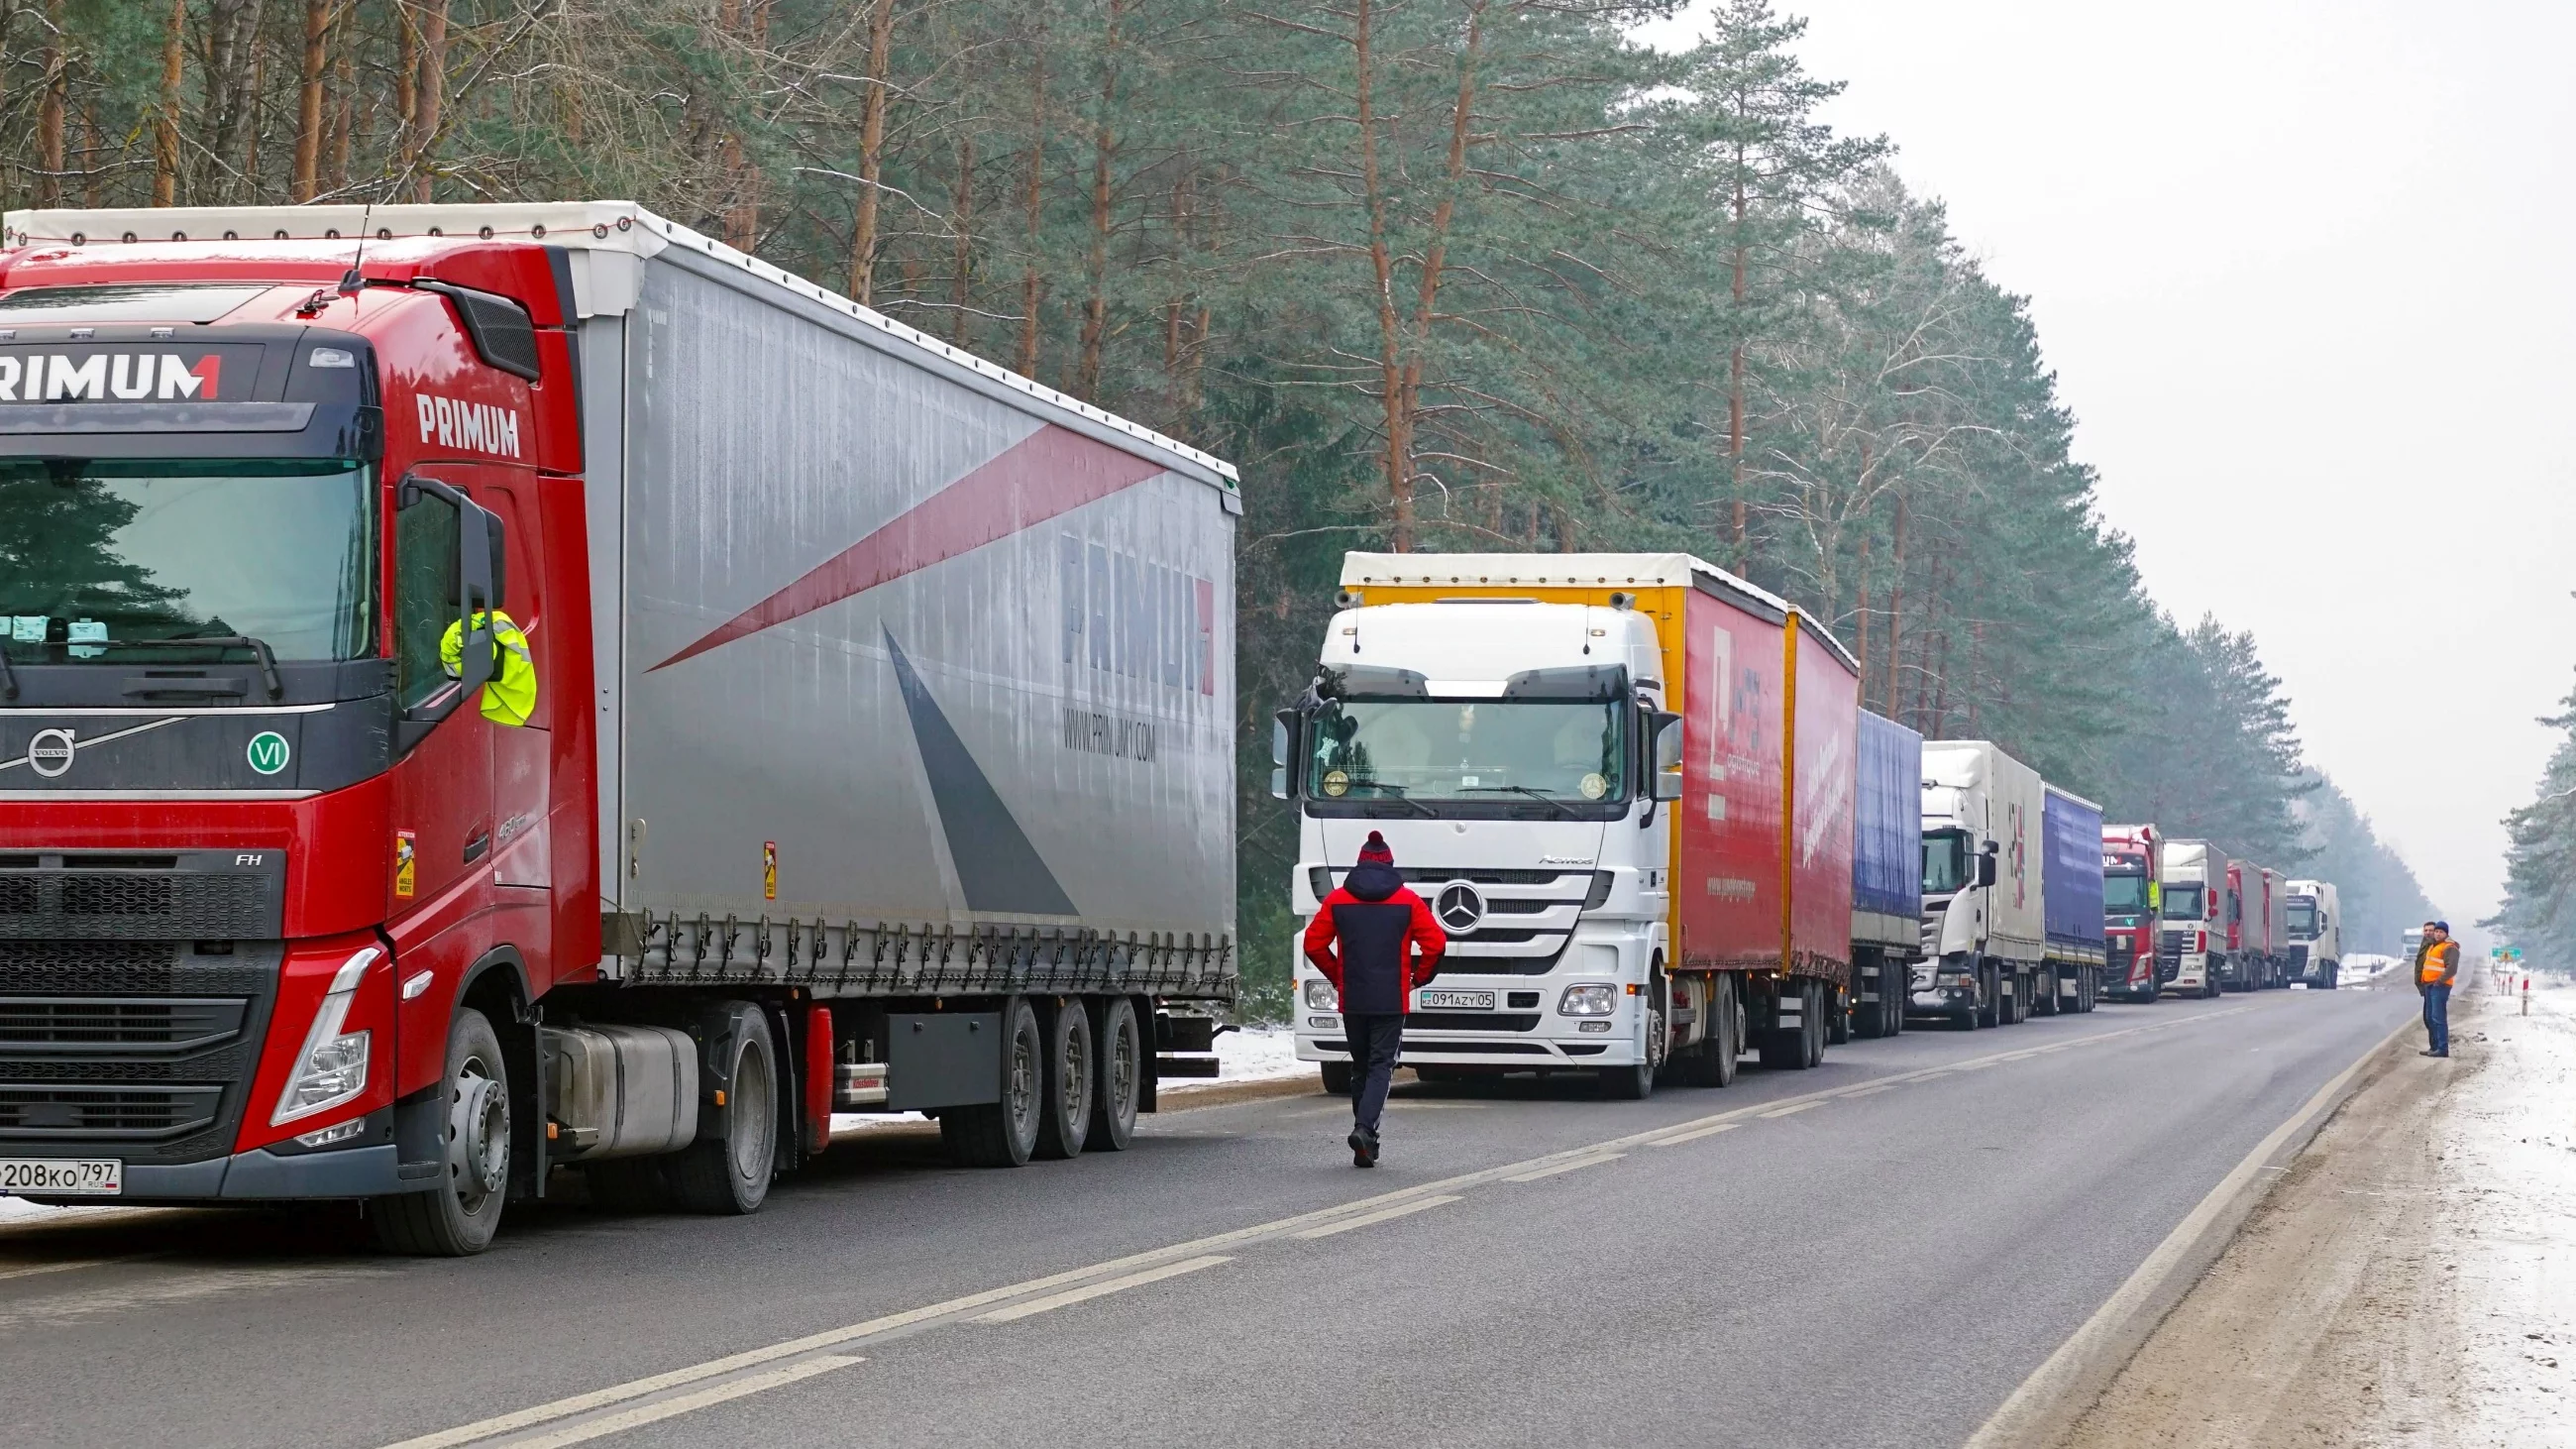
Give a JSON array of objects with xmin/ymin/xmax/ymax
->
[{"xmin": 383, "ymin": 1006, "xmax": 2254, "ymax": 1449}]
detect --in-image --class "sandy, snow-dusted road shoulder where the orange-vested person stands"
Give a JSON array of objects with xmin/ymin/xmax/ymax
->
[{"xmin": 2032, "ymin": 993, "xmax": 2576, "ymax": 1449}]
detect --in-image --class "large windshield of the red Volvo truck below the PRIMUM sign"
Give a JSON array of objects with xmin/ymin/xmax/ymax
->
[{"xmin": 0, "ymin": 459, "xmax": 376, "ymax": 663}]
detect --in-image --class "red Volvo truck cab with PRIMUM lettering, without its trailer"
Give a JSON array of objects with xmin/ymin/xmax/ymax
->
[{"xmin": 0, "ymin": 243, "xmax": 600, "ymax": 1216}]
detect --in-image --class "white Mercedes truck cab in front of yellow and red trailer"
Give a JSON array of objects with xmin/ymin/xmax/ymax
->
[{"xmin": 1272, "ymin": 596, "xmax": 1679, "ymax": 1096}]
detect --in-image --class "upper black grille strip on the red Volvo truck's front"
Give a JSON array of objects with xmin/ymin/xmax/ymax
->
[{"xmin": 0, "ymin": 850, "xmax": 286, "ymax": 942}]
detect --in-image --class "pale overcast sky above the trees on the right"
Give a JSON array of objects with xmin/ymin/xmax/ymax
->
[{"xmin": 1649, "ymin": 0, "xmax": 2576, "ymax": 944}]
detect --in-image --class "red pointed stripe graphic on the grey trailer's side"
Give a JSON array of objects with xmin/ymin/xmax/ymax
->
[{"xmin": 644, "ymin": 423, "xmax": 1164, "ymax": 673}]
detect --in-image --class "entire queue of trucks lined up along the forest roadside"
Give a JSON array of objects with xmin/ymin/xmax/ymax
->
[{"xmin": 0, "ymin": 201, "xmax": 2339, "ymax": 1256}]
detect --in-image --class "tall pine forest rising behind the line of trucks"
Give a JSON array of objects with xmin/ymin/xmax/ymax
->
[{"xmin": 0, "ymin": 0, "xmax": 2421, "ymax": 1005}]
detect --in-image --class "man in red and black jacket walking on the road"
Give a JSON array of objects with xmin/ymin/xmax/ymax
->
[{"xmin": 1306, "ymin": 831, "xmax": 1448, "ymax": 1168}]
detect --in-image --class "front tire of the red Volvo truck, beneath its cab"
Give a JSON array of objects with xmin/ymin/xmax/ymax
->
[{"xmin": 366, "ymin": 1006, "xmax": 512, "ymax": 1258}]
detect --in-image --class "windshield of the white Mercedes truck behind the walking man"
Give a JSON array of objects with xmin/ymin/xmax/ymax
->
[{"xmin": 1306, "ymin": 699, "xmax": 1628, "ymax": 802}]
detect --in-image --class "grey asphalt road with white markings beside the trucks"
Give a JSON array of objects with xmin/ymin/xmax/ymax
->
[{"xmin": 0, "ymin": 985, "xmax": 2416, "ymax": 1449}]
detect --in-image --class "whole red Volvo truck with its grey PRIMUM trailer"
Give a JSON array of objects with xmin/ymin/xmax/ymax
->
[{"xmin": 0, "ymin": 204, "xmax": 1239, "ymax": 1253}]
